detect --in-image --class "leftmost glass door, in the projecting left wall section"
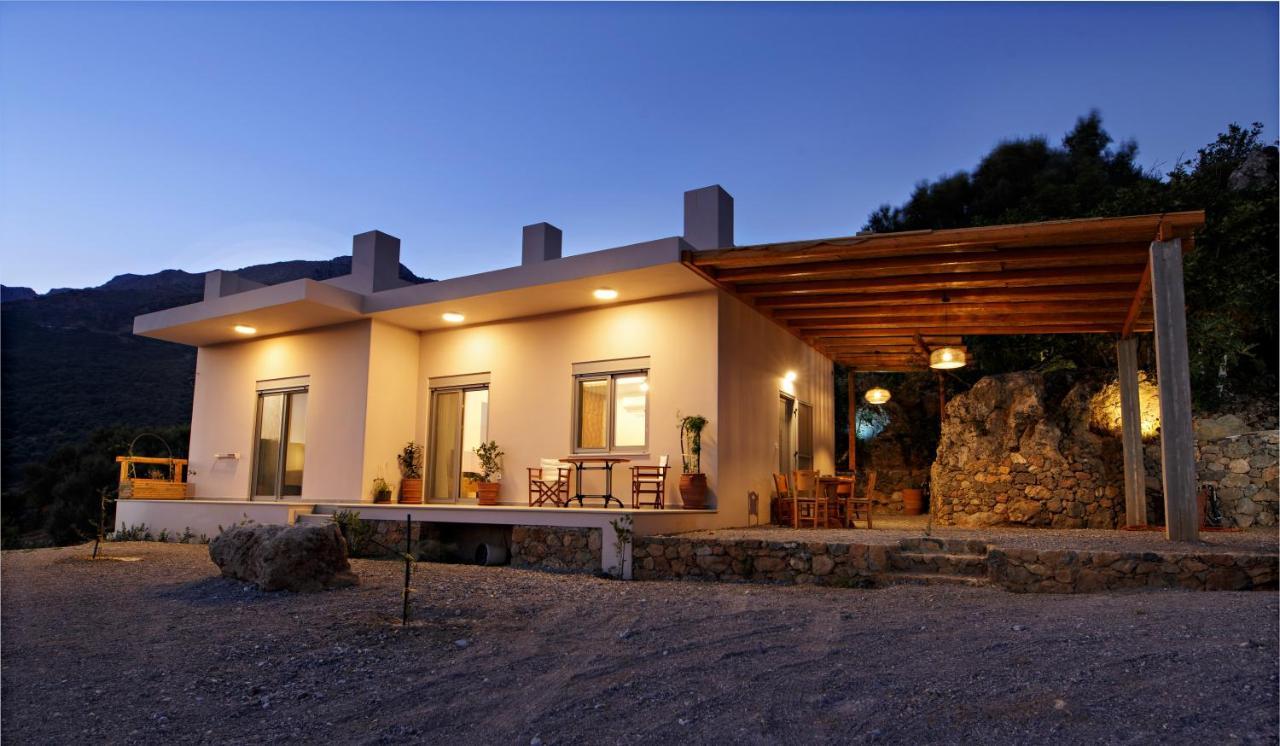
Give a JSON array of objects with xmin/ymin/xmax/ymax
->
[{"xmin": 253, "ymin": 377, "xmax": 307, "ymax": 500}]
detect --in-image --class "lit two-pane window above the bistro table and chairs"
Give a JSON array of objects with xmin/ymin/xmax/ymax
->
[{"xmin": 573, "ymin": 370, "xmax": 649, "ymax": 453}]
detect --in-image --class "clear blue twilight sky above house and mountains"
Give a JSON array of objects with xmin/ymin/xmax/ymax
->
[{"xmin": 0, "ymin": 3, "xmax": 1280, "ymax": 290}]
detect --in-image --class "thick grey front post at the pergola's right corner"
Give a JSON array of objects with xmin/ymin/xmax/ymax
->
[{"xmin": 1151, "ymin": 238, "xmax": 1199, "ymax": 541}]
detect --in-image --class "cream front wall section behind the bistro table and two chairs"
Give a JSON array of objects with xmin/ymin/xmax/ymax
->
[{"xmin": 417, "ymin": 290, "xmax": 719, "ymax": 507}]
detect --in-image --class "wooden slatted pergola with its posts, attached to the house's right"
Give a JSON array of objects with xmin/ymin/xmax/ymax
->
[{"xmin": 684, "ymin": 211, "xmax": 1204, "ymax": 540}]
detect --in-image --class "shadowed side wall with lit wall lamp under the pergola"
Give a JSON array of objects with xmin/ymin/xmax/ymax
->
[{"xmin": 718, "ymin": 292, "xmax": 836, "ymax": 526}]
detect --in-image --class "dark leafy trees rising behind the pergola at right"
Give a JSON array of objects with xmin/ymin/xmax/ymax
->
[{"xmin": 865, "ymin": 111, "xmax": 1277, "ymax": 407}]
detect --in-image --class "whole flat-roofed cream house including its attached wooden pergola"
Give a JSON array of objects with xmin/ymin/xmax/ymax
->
[{"xmin": 116, "ymin": 186, "xmax": 1204, "ymax": 567}]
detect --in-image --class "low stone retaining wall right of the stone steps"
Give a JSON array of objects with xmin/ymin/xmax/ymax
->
[{"xmin": 987, "ymin": 549, "xmax": 1277, "ymax": 594}]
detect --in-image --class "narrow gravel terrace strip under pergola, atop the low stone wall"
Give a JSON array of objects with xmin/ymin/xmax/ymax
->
[{"xmin": 701, "ymin": 516, "xmax": 1280, "ymax": 554}]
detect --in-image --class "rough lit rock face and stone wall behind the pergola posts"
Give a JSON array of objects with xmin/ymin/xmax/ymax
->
[{"xmin": 931, "ymin": 372, "xmax": 1280, "ymax": 528}]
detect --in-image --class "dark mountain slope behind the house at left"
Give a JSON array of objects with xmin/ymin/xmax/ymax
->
[{"xmin": 0, "ymin": 256, "xmax": 431, "ymax": 488}]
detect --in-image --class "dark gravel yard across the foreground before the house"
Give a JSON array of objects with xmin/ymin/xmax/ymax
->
[{"xmin": 0, "ymin": 543, "xmax": 1280, "ymax": 743}]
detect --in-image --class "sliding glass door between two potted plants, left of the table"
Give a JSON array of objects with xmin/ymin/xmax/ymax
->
[{"xmin": 428, "ymin": 386, "xmax": 489, "ymax": 502}]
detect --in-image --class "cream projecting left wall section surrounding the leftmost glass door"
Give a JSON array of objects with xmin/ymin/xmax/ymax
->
[{"xmin": 189, "ymin": 321, "xmax": 373, "ymax": 503}]
